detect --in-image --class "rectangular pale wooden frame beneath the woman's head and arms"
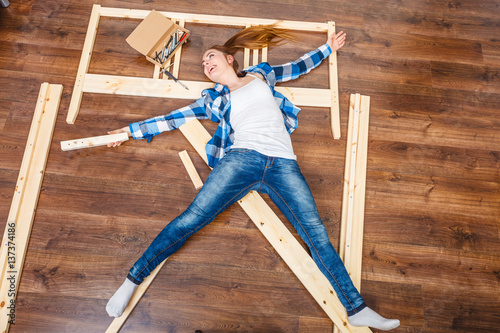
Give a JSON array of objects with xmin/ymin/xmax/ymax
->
[{"xmin": 66, "ymin": 5, "xmax": 340, "ymax": 139}]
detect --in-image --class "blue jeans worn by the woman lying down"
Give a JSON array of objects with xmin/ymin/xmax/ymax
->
[{"xmin": 127, "ymin": 149, "xmax": 366, "ymax": 315}]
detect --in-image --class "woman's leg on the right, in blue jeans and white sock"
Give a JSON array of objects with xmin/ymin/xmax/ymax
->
[{"xmin": 261, "ymin": 158, "xmax": 399, "ymax": 329}]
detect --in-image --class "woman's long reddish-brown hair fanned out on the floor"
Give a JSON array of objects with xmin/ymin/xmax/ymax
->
[{"xmin": 209, "ymin": 24, "xmax": 297, "ymax": 76}]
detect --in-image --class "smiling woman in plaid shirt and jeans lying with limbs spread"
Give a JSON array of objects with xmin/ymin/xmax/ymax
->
[{"xmin": 106, "ymin": 26, "xmax": 399, "ymax": 330}]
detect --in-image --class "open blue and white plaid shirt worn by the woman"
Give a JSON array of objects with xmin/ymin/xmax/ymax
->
[{"xmin": 129, "ymin": 44, "xmax": 332, "ymax": 167}]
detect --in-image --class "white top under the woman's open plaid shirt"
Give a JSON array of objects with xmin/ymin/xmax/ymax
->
[{"xmin": 229, "ymin": 73, "xmax": 297, "ymax": 160}]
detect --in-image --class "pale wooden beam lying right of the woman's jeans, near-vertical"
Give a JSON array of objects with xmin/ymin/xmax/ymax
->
[{"xmin": 334, "ymin": 94, "xmax": 370, "ymax": 333}]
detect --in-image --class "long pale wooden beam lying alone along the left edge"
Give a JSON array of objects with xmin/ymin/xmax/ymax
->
[{"xmin": 0, "ymin": 82, "xmax": 63, "ymax": 332}]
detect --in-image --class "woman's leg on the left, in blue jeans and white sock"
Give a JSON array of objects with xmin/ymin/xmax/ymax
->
[{"xmin": 106, "ymin": 150, "xmax": 263, "ymax": 317}]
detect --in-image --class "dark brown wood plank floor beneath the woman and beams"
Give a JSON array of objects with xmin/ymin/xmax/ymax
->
[{"xmin": 0, "ymin": 0, "xmax": 500, "ymax": 333}]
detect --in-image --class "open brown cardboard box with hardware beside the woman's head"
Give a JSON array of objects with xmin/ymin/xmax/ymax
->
[{"xmin": 127, "ymin": 10, "xmax": 189, "ymax": 68}]
